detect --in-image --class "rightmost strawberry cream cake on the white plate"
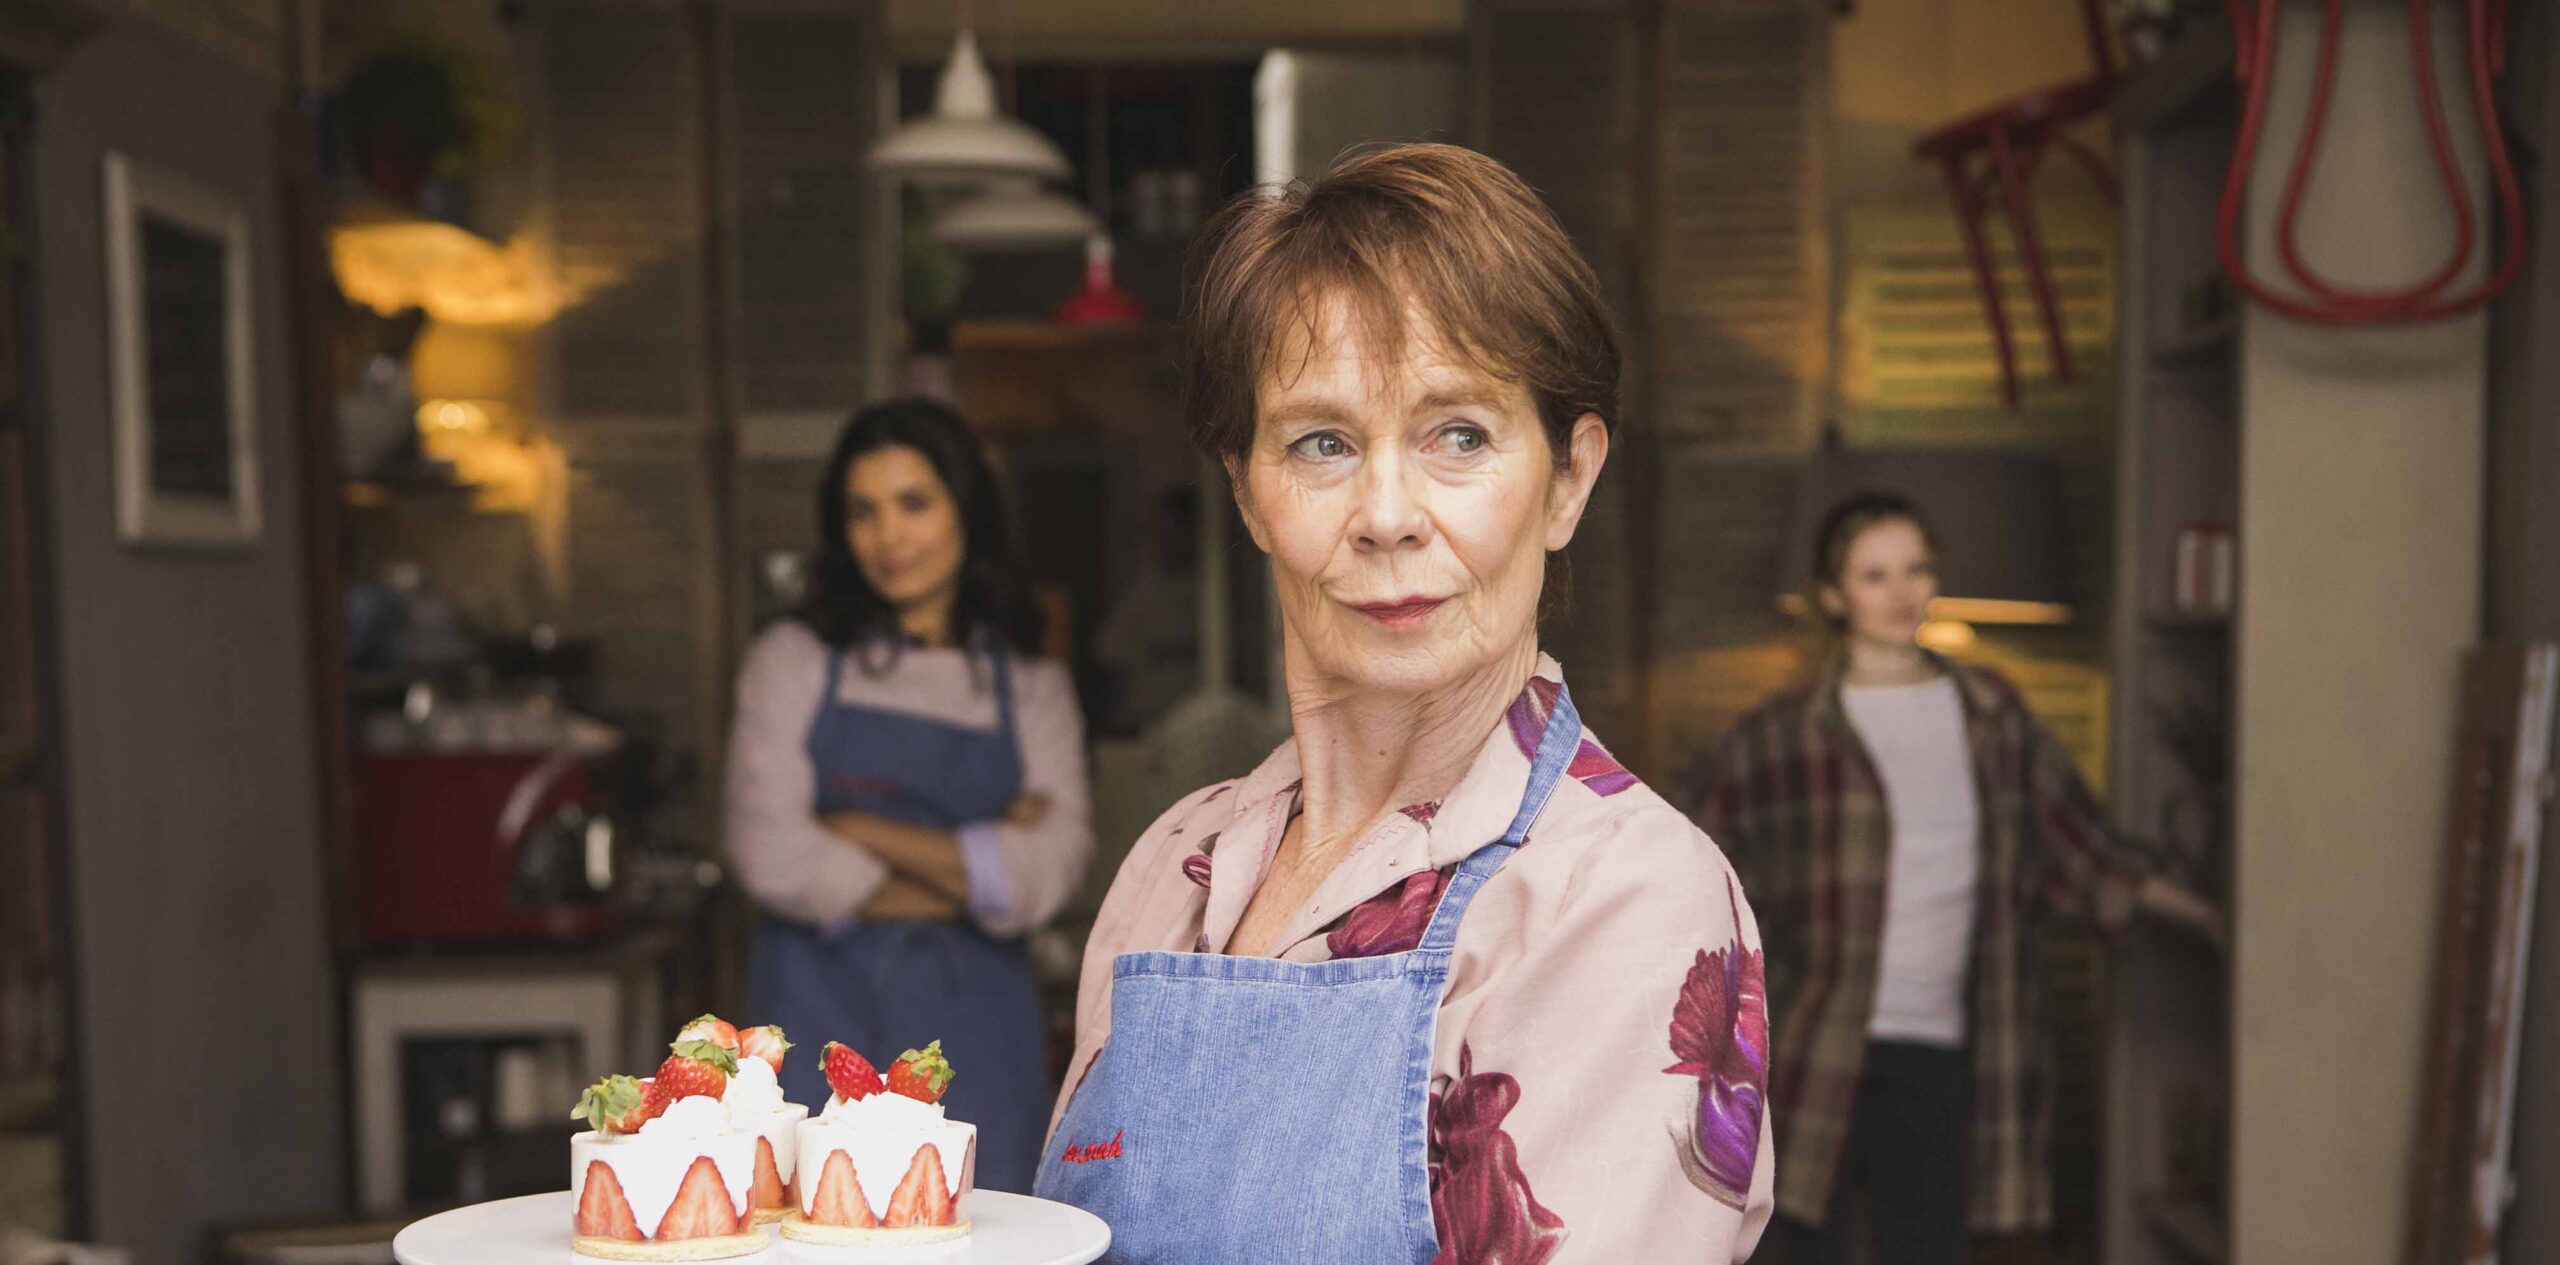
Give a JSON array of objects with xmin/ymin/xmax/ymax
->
[{"xmin": 783, "ymin": 1042, "xmax": 978, "ymax": 1245}]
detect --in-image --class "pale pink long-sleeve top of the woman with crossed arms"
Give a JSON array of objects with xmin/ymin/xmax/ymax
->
[{"xmin": 722, "ymin": 620, "xmax": 1093, "ymax": 935}]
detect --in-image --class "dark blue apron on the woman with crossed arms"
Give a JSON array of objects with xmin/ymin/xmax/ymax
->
[{"xmin": 748, "ymin": 648, "xmax": 1052, "ymax": 1191}]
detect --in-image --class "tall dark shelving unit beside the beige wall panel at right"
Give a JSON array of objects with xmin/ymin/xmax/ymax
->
[{"xmin": 2099, "ymin": 41, "xmax": 2260, "ymax": 1265}]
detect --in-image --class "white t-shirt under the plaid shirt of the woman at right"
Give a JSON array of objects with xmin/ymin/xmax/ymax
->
[{"xmin": 1841, "ymin": 676, "xmax": 1981, "ymax": 1047}]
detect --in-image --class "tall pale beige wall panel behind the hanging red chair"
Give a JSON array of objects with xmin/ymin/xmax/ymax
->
[{"xmin": 2232, "ymin": 5, "xmax": 2486, "ymax": 1265}]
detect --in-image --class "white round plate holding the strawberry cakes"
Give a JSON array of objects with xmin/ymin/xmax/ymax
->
[{"xmin": 392, "ymin": 1191, "xmax": 1111, "ymax": 1265}]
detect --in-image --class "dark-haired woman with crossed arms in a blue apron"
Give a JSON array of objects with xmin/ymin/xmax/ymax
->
[{"xmin": 724, "ymin": 399, "xmax": 1093, "ymax": 1191}]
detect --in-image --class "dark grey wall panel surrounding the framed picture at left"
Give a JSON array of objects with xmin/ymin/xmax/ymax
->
[{"xmin": 33, "ymin": 18, "xmax": 343, "ymax": 1265}]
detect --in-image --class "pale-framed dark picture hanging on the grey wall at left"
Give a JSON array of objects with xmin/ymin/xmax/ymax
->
[{"xmin": 105, "ymin": 151, "xmax": 259, "ymax": 548}]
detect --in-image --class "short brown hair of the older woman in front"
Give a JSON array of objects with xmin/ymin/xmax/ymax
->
[{"xmin": 1183, "ymin": 143, "xmax": 1618, "ymax": 466}]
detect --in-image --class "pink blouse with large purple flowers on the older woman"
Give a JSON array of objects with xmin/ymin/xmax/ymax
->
[{"xmin": 1052, "ymin": 658, "xmax": 1774, "ymax": 1265}]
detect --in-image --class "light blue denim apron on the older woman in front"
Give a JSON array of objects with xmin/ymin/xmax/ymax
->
[{"xmin": 1034, "ymin": 694, "xmax": 1582, "ymax": 1265}]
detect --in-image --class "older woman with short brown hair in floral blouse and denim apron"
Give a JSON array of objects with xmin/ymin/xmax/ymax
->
[{"xmin": 1037, "ymin": 146, "xmax": 1772, "ymax": 1265}]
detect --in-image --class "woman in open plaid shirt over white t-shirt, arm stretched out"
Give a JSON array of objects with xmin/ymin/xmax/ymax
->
[{"xmin": 1695, "ymin": 492, "xmax": 2222, "ymax": 1265}]
